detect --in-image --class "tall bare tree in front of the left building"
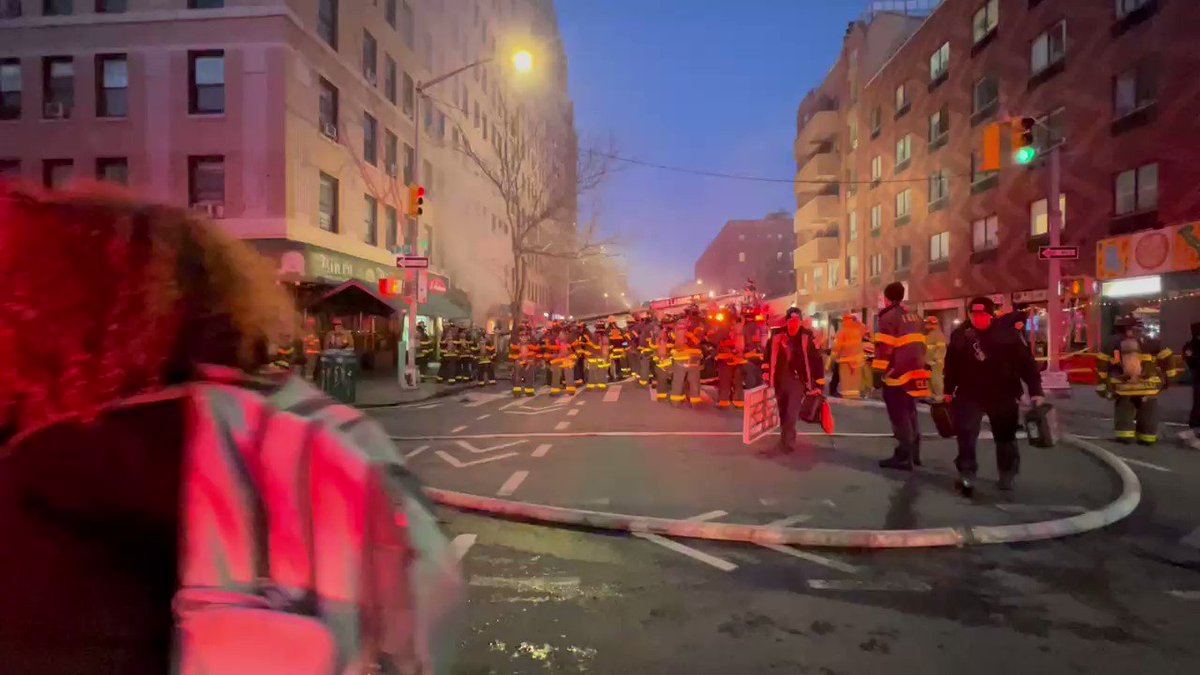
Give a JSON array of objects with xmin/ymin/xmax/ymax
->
[{"xmin": 455, "ymin": 99, "xmax": 617, "ymax": 328}]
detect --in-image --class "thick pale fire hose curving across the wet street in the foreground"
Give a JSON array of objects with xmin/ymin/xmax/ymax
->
[{"xmin": 425, "ymin": 436, "xmax": 1141, "ymax": 549}]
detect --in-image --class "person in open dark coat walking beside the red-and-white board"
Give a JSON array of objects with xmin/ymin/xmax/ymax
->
[{"xmin": 770, "ymin": 307, "xmax": 824, "ymax": 453}]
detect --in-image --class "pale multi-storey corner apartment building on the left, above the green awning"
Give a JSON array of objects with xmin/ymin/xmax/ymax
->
[{"xmin": 0, "ymin": 0, "xmax": 576, "ymax": 324}]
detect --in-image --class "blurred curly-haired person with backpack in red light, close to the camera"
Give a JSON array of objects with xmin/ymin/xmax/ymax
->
[{"xmin": 0, "ymin": 185, "xmax": 461, "ymax": 675}]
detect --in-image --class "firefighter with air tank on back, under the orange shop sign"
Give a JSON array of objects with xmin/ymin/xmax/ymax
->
[{"xmin": 1096, "ymin": 317, "xmax": 1176, "ymax": 446}]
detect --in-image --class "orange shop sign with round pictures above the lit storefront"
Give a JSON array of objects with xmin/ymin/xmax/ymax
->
[{"xmin": 1096, "ymin": 222, "xmax": 1200, "ymax": 280}]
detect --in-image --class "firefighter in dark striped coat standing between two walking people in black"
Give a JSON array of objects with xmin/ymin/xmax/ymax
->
[{"xmin": 871, "ymin": 281, "xmax": 929, "ymax": 471}]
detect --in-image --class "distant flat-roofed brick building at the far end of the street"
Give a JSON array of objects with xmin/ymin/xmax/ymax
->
[{"xmin": 696, "ymin": 211, "xmax": 796, "ymax": 298}]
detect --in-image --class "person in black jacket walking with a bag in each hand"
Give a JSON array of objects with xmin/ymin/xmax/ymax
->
[{"xmin": 946, "ymin": 298, "xmax": 1043, "ymax": 496}]
